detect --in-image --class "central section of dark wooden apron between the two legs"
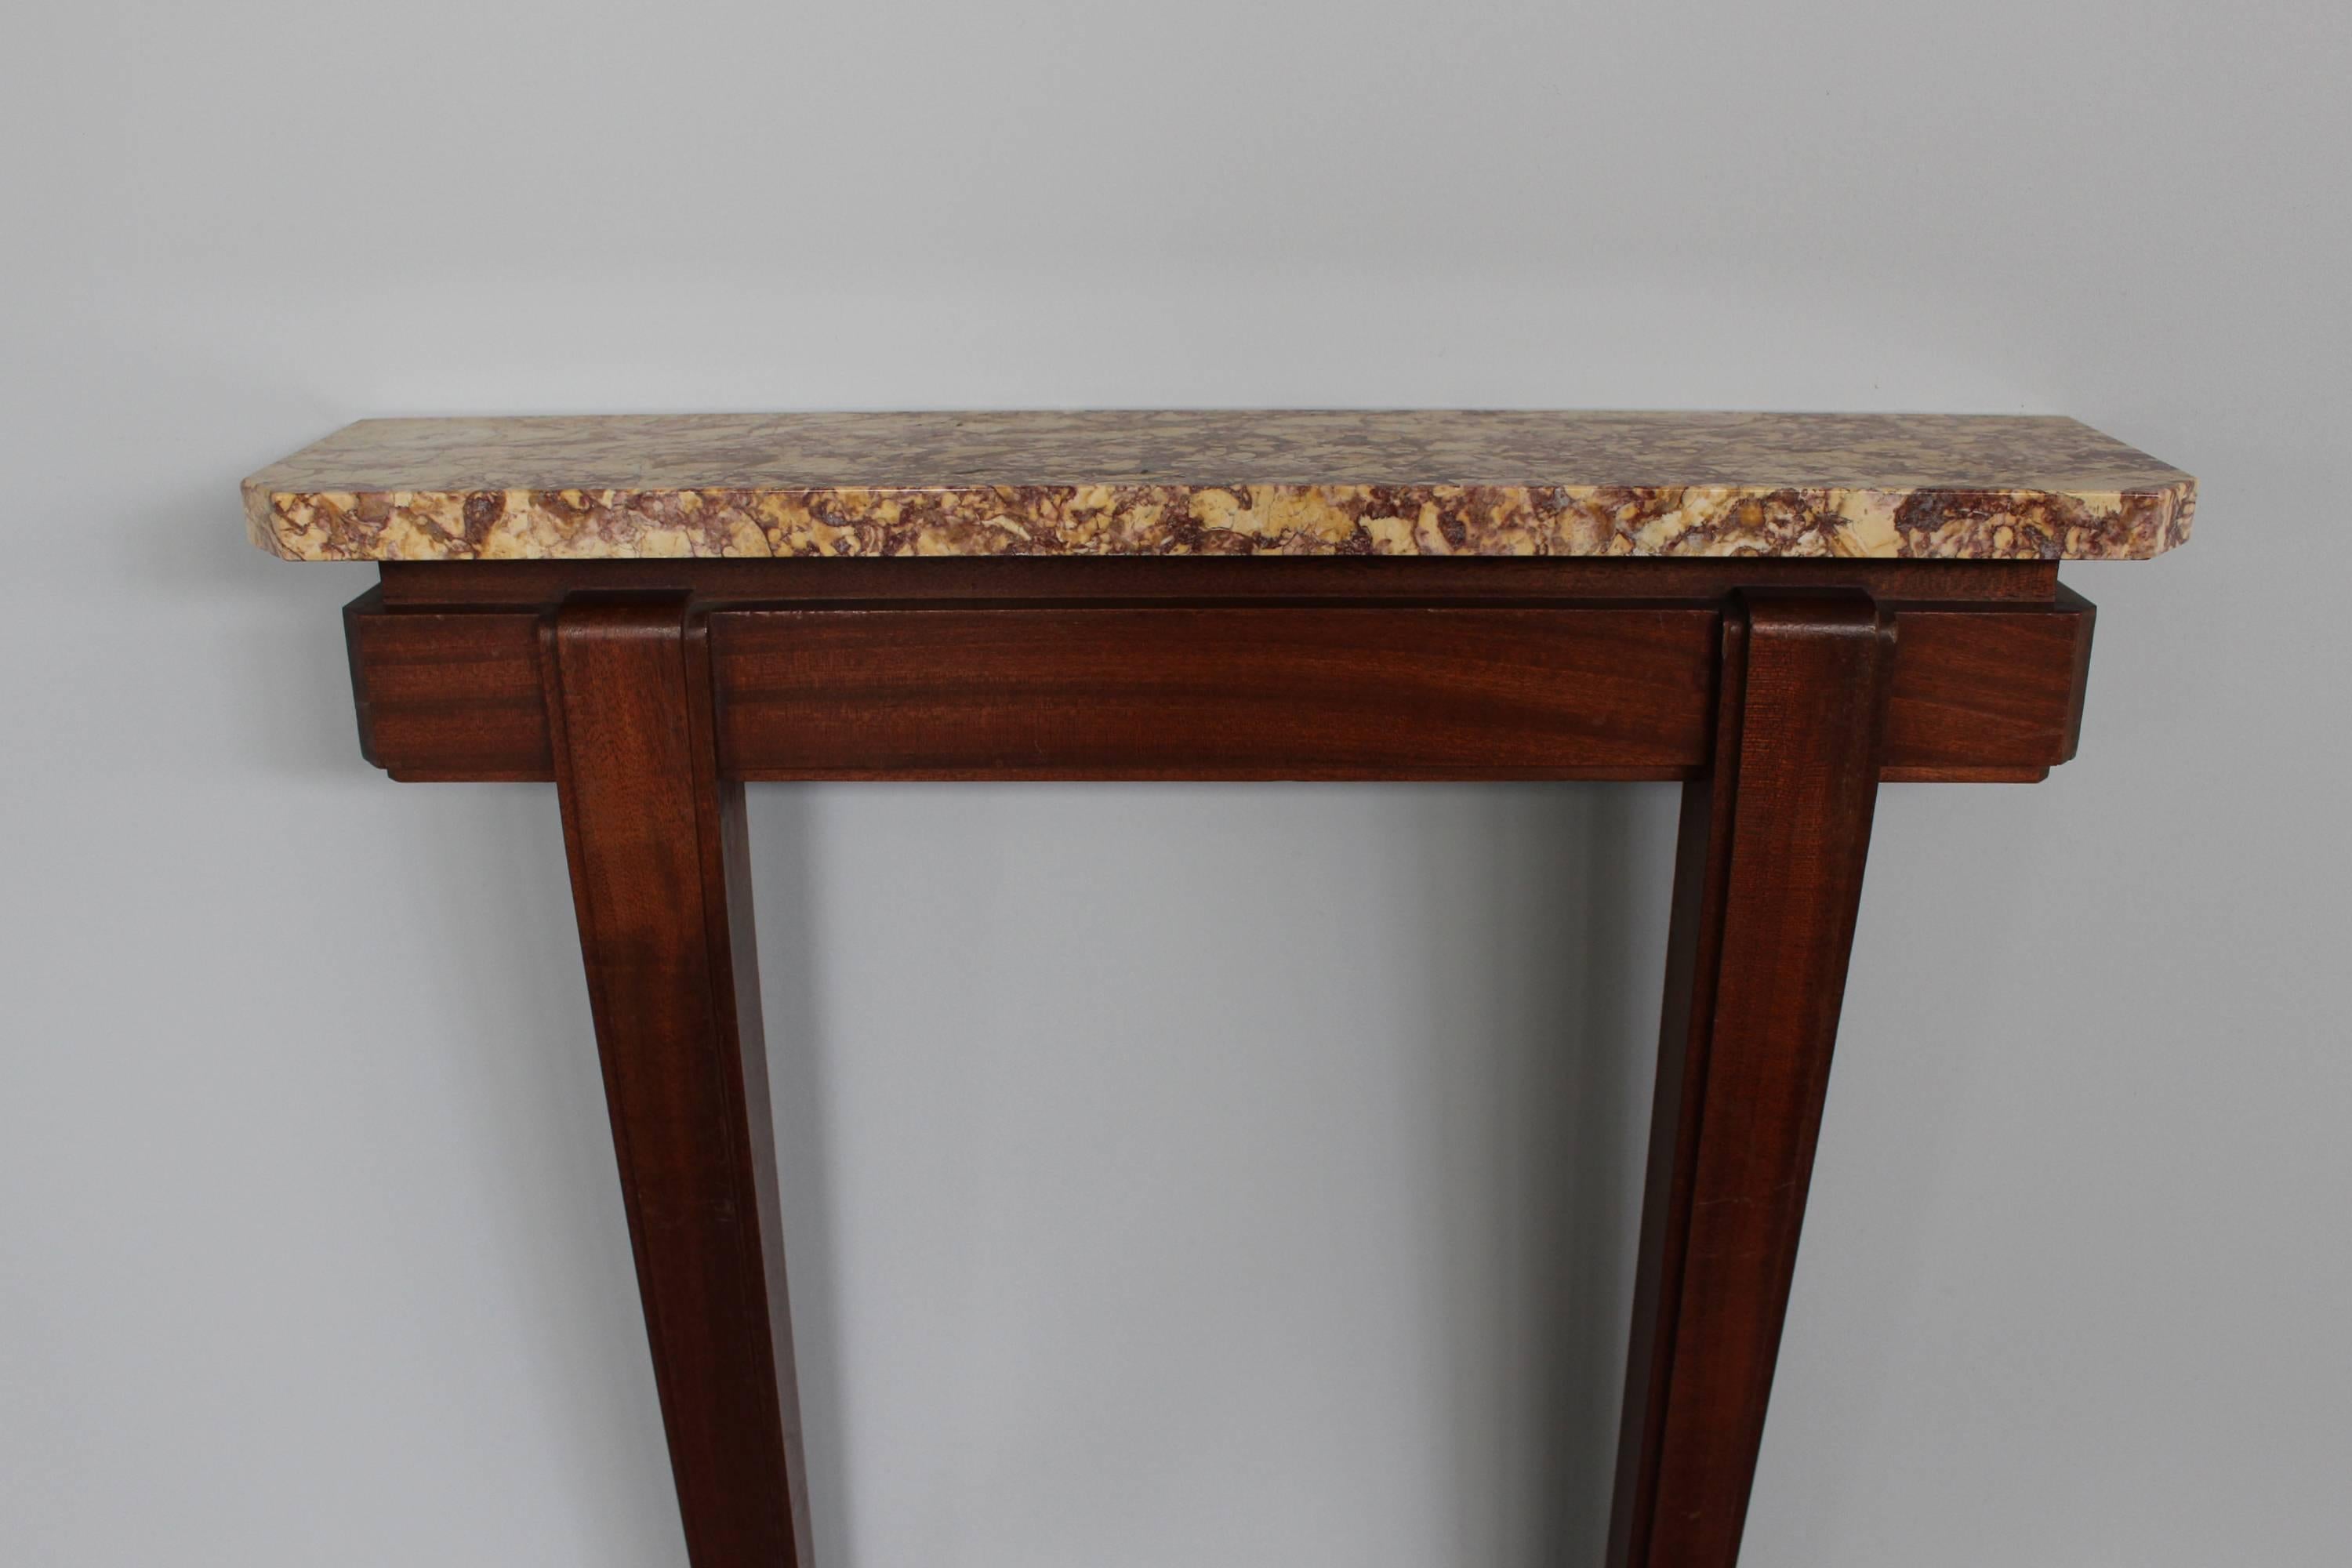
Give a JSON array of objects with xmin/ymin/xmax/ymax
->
[{"xmin": 710, "ymin": 607, "xmax": 1715, "ymax": 779}]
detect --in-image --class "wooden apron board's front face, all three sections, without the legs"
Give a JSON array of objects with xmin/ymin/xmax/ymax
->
[{"xmin": 348, "ymin": 595, "xmax": 2091, "ymax": 781}]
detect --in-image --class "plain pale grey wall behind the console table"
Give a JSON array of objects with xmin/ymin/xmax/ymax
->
[{"xmin": 0, "ymin": 0, "xmax": 2352, "ymax": 1568}]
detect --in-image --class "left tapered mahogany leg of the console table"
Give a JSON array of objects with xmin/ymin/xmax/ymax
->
[{"xmin": 543, "ymin": 600, "xmax": 809, "ymax": 1568}]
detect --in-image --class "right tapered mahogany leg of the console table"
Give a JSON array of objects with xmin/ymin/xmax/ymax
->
[{"xmin": 1609, "ymin": 597, "xmax": 1893, "ymax": 1568}]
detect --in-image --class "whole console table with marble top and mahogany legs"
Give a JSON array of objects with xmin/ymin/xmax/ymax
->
[{"xmin": 245, "ymin": 412, "xmax": 2194, "ymax": 1568}]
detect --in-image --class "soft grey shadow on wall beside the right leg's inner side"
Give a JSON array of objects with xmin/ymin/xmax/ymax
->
[{"xmin": 1428, "ymin": 785, "xmax": 1675, "ymax": 1568}]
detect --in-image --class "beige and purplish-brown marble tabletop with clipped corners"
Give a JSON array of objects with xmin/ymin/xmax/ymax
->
[{"xmin": 245, "ymin": 409, "xmax": 2197, "ymax": 560}]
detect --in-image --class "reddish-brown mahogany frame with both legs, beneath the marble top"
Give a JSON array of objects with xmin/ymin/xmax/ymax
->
[{"xmin": 346, "ymin": 557, "xmax": 2093, "ymax": 1568}]
